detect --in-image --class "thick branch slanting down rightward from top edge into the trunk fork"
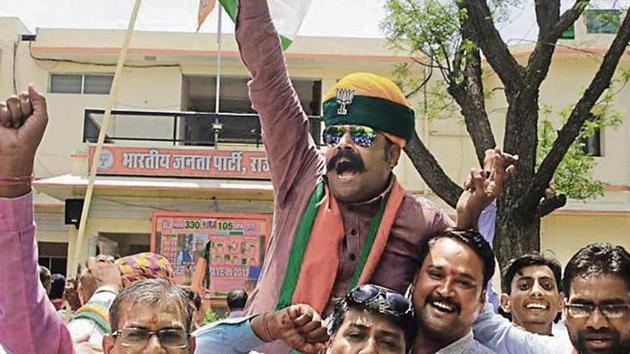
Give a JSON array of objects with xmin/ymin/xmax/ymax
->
[{"xmin": 458, "ymin": 0, "xmax": 525, "ymax": 95}]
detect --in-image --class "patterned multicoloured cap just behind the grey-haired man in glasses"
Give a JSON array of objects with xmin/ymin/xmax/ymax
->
[{"xmin": 115, "ymin": 252, "xmax": 175, "ymax": 287}]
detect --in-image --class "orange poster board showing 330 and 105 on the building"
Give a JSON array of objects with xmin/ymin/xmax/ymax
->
[{"xmin": 151, "ymin": 211, "xmax": 271, "ymax": 295}]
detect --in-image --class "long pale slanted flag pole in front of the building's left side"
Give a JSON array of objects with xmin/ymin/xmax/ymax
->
[{"xmin": 69, "ymin": 0, "xmax": 142, "ymax": 277}]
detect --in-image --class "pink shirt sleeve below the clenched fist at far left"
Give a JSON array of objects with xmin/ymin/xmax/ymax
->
[{"xmin": 0, "ymin": 194, "xmax": 72, "ymax": 353}]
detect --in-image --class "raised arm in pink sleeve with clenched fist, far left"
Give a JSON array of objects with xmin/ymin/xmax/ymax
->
[{"xmin": 0, "ymin": 87, "xmax": 72, "ymax": 353}]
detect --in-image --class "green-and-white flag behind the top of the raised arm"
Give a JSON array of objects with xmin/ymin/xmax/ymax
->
[{"xmin": 218, "ymin": 0, "xmax": 311, "ymax": 49}]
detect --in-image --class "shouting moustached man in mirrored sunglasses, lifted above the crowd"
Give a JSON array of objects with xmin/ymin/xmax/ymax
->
[{"xmin": 236, "ymin": 0, "xmax": 514, "ymax": 354}]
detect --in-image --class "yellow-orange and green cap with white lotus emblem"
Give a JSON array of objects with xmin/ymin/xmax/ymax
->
[{"xmin": 323, "ymin": 73, "xmax": 415, "ymax": 147}]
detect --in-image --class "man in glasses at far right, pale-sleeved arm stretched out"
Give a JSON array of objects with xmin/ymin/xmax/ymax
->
[{"xmin": 474, "ymin": 243, "xmax": 630, "ymax": 354}]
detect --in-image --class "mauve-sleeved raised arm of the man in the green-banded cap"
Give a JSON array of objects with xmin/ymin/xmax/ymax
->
[{"xmin": 236, "ymin": 0, "xmax": 324, "ymax": 205}]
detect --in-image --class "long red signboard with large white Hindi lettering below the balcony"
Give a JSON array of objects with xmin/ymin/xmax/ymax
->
[{"xmin": 88, "ymin": 146, "xmax": 270, "ymax": 179}]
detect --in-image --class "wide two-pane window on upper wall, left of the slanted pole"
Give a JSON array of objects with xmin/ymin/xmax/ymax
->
[{"xmin": 49, "ymin": 74, "xmax": 114, "ymax": 95}]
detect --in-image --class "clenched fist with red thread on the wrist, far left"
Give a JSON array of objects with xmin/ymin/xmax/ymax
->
[{"xmin": 0, "ymin": 85, "xmax": 48, "ymax": 198}]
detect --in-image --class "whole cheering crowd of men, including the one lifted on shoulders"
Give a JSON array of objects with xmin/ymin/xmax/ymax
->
[{"xmin": 0, "ymin": 0, "xmax": 630, "ymax": 354}]
